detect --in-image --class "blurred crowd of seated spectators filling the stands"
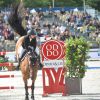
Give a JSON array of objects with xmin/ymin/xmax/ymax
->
[{"xmin": 0, "ymin": 8, "xmax": 100, "ymax": 50}]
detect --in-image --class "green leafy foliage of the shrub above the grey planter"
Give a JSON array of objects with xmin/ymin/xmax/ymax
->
[{"xmin": 65, "ymin": 37, "xmax": 89, "ymax": 78}]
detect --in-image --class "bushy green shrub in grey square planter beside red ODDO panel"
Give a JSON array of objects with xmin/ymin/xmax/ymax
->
[{"xmin": 65, "ymin": 37, "xmax": 89, "ymax": 94}]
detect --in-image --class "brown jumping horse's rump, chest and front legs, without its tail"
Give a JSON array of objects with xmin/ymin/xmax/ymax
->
[{"xmin": 15, "ymin": 36, "xmax": 38, "ymax": 100}]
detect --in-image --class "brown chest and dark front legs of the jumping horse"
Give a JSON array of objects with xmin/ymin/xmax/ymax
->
[{"xmin": 20, "ymin": 52, "xmax": 38, "ymax": 100}]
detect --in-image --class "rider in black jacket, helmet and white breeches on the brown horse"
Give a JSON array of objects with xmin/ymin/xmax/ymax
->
[{"xmin": 16, "ymin": 29, "xmax": 37, "ymax": 70}]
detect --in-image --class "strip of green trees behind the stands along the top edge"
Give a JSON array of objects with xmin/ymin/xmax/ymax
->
[{"xmin": 0, "ymin": 0, "xmax": 100, "ymax": 10}]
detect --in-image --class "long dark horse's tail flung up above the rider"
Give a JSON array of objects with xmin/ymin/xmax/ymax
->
[{"xmin": 8, "ymin": 3, "xmax": 27, "ymax": 36}]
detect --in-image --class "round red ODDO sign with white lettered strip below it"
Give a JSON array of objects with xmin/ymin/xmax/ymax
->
[{"xmin": 41, "ymin": 40, "xmax": 65, "ymax": 68}]
